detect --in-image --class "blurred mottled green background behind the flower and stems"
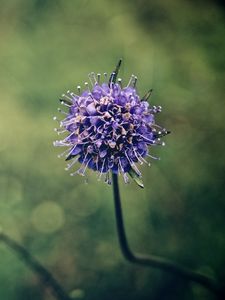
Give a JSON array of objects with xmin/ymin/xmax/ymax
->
[{"xmin": 0, "ymin": 0, "xmax": 225, "ymax": 300}]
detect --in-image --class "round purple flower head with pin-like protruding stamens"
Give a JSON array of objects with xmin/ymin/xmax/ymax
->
[{"xmin": 54, "ymin": 60, "xmax": 169, "ymax": 186}]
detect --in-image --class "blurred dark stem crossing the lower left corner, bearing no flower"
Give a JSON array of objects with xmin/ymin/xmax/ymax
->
[{"xmin": 0, "ymin": 233, "xmax": 71, "ymax": 300}]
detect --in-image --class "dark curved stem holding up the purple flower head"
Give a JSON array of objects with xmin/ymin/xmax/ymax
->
[{"xmin": 112, "ymin": 174, "xmax": 225, "ymax": 299}]
